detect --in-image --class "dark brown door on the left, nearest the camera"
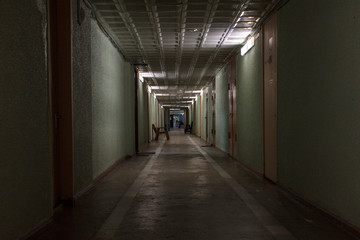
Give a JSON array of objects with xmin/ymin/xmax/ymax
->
[{"xmin": 48, "ymin": 0, "xmax": 74, "ymax": 207}]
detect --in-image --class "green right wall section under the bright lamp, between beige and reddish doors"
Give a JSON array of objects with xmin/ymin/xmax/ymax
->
[{"xmin": 236, "ymin": 35, "xmax": 263, "ymax": 173}]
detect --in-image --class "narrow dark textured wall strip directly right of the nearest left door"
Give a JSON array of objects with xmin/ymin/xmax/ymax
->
[{"xmin": 72, "ymin": 1, "xmax": 93, "ymax": 193}]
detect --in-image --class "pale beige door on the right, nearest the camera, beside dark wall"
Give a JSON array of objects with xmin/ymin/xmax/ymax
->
[{"xmin": 263, "ymin": 14, "xmax": 277, "ymax": 182}]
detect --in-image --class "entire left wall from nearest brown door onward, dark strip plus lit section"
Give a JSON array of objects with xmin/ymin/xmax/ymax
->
[{"xmin": 72, "ymin": 1, "xmax": 135, "ymax": 188}]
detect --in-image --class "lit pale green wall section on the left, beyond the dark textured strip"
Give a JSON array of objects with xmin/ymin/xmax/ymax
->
[{"xmin": 91, "ymin": 21, "xmax": 135, "ymax": 177}]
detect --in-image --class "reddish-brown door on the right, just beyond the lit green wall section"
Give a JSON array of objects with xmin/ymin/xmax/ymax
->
[{"xmin": 228, "ymin": 56, "xmax": 237, "ymax": 158}]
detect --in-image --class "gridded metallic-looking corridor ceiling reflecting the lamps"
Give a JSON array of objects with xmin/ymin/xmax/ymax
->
[{"xmin": 91, "ymin": 0, "xmax": 277, "ymax": 105}]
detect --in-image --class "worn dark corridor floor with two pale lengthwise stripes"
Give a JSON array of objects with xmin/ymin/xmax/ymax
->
[{"xmin": 33, "ymin": 130, "xmax": 356, "ymax": 240}]
